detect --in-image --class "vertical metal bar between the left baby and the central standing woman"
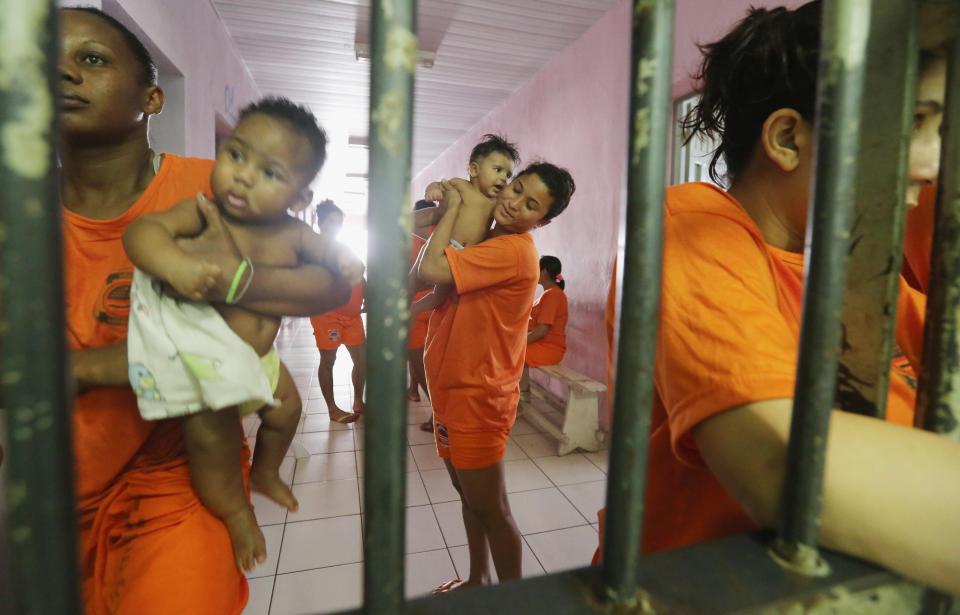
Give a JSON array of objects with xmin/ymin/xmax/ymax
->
[{"xmin": 363, "ymin": 0, "xmax": 417, "ymax": 614}]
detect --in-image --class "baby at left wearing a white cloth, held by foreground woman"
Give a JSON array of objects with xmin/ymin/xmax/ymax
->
[{"xmin": 123, "ymin": 98, "xmax": 363, "ymax": 570}]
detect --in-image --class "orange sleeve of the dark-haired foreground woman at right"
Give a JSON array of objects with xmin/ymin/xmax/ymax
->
[{"xmin": 654, "ymin": 213, "xmax": 797, "ymax": 463}]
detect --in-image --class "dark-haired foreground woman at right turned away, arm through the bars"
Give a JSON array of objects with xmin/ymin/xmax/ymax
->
[{"xmin": 596, "ymin": 2, "xmax": 960, "ymax": 593}]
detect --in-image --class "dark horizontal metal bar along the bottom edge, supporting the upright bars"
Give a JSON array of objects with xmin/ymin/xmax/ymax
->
[{"xmin": 334, "ymin": 536, "xmax": 932, "ymax": 615}]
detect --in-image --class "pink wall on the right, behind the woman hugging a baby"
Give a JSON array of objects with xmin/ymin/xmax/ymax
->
[{"xmin": 413, "ymin": 0, "xmax": 801, "ymax": 426}]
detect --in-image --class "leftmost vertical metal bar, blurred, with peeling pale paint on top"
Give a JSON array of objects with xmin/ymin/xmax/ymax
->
[{"xmin": 0, "ymin": 0, "xmax": 80, "ymax": 615}]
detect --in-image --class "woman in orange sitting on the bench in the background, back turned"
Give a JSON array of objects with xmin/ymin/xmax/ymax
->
[{"xmin": 520, "ymin": 256, "xmax": 567, "ymax": 398}]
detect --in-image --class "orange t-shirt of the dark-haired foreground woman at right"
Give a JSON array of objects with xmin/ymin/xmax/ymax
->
[{"xmin": 643, "ymin": 184, "xmax": 925, "ymax": 551}]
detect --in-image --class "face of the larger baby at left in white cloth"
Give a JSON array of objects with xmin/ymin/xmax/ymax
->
[{"xmin": 211, "ymin": 113, "xmax": 313, "ymax": 222}]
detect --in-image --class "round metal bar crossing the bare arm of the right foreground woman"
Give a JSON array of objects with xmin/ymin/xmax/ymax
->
[{"xmin": 775, "ymin": 0, "xmax": 871, "ymax": 574}]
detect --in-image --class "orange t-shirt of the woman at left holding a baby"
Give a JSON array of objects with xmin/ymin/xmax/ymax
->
[{"xmin": 63, "ymin": 154, "xmax": 213, "ymax": 508}]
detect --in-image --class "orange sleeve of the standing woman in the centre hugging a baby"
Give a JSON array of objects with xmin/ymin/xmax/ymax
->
[{"xmin": 445, "ymin": 236, "xmax": 520, "ymax": 295}]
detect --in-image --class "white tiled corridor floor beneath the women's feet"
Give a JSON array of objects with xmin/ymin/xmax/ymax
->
[{"xmin": 244, "ymin": 319, "xmax": 607, "ymax": 615}]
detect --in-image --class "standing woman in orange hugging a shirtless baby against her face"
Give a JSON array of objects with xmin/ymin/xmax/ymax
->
[{"xmin": 419, "ymin": 163, "xmax": 575, "ymax": 591}]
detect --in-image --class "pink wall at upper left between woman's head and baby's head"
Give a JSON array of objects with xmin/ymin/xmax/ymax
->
[{"xmin": 60, "ymin": 0, "xmax": 259, "ymax": 158}]
